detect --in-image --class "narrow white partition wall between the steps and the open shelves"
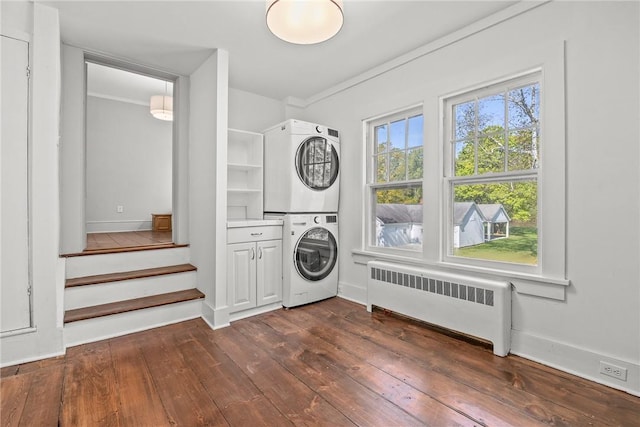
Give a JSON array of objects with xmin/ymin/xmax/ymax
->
[{"xmin": 189, "ymin": 50, "xmax": 229, "ymax": 326}]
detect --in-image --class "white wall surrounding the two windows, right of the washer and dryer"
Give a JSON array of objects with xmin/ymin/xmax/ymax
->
[{"xmin": 299, "ymin": 2, "xmax": 640, "ymax": 394}]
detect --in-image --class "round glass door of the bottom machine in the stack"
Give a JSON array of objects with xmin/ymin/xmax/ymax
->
[{"xmin": 294, "ymin": 227, "xmax": 338, "ymax": 282}]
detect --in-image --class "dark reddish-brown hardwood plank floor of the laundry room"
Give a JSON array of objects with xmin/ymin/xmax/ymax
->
[{"xmin": 0, "ymin": 298, "xmax": 640, "ymax": 426}]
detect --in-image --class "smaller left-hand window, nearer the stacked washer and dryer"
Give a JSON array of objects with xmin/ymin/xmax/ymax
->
[{"xmin": 366, "ymin": 108, "xmax": 424, "ymax": 252}]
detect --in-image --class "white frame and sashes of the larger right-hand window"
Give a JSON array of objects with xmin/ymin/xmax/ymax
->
[{"xmin": 441, "ymin": 69, "xmax": 544, "ymax": 276}]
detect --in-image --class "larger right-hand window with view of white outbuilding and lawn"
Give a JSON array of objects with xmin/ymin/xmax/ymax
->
[{"xmin": 444, "ymin": 73, "xmax": 545, "ymax": 266}]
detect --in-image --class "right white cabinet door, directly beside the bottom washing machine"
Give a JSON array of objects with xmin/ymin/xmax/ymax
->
[{"xmin": 257, "ymin": 240, "xmax": 282, "ymax": 306}]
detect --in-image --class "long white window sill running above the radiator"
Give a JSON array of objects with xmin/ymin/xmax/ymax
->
[{"xmin": 351, "ymin": 249, "xmax": 571, "ymax": 301}]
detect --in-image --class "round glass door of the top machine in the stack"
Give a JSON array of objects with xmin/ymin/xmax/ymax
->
[{"xmin": 296, "ymin": 136, "xmax": 338, "ymax": 191}]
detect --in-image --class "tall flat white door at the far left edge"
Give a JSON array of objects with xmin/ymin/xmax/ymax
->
[{"xmin": 0, "ymin": 36, "xmax": 31, "ymax": 332}]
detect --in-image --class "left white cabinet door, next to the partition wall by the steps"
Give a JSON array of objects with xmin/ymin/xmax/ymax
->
[{"xmin": 227, "ymin": 242, "xmax": 257, "ymax": 313}]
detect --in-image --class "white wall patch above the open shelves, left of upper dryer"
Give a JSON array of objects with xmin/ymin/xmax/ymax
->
[{"xmin": 229, "ymin": 88, "xmax": 285, "ymax": 133}]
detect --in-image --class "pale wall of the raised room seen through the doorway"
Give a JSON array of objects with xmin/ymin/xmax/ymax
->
[{"xmin": 86, "ymin": 96, "xmax": 173, "ymax": 232}]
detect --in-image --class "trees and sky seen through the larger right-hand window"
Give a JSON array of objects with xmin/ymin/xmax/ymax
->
[{"xmin": 453, "ymin": 84, "xmax": 540, "ymax": 225}]
